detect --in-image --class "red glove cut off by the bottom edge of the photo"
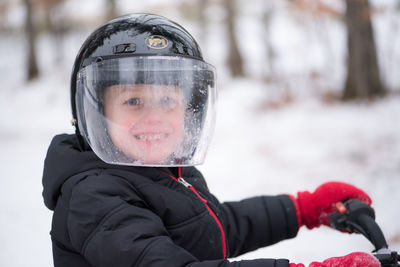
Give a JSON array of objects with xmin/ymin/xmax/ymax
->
[{"xmin": 289, "ymin": 252, "xmax": 381, "ymax": 267}]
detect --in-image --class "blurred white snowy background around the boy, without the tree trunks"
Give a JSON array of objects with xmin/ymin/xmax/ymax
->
[{"xmin": 0, "ymin": 0, "xmax": 400, "ymax": 267}]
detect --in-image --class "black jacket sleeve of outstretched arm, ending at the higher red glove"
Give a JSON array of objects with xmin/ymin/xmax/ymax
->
[{"xmin": 221, "ymin": 195, "xmax": 298, "ymax": 257}]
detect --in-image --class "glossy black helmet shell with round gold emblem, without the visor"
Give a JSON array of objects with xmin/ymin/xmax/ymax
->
[{"xmin": 71, "ymin": 14, "xmax": 204, "ymax": 150}]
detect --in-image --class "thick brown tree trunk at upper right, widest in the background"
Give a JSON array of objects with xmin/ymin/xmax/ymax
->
[{"xmin": 342, "ymin": 0, "xmax": 386, "ymax": 100}]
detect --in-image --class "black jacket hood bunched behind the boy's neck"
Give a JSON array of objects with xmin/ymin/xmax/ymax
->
[{"xmin": 42, "ymin": 134, "xmax": 109, "ymax": 210}]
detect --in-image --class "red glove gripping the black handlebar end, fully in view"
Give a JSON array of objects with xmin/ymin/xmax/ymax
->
[{"xmin": 291, "ymin": 182, "xmax": 372, "ymax": 229}]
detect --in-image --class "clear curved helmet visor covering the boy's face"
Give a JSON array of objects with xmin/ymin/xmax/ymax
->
[{"xmin": 76, "ymin": 56, "xmax": 216, "ymax": 166}]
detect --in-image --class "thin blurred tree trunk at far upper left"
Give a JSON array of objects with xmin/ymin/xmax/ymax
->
[{"xmin": 24, "ymin": 0, "xmax": 39, "ymax": 81}]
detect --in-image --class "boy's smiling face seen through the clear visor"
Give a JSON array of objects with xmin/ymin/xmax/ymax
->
[{"xmin": 104, "ymin": 84, "xmax": 185, "ymax": 165}]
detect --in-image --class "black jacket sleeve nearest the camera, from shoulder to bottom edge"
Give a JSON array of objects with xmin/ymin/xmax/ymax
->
[{"xmin": 68, "ymin": 176, "xmax": 289, "ymax": 267}]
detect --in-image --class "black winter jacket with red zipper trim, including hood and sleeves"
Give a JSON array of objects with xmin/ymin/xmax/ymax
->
[{"xmin": 43, "ymin": 134, "xmax": 297, "ymax": 267}]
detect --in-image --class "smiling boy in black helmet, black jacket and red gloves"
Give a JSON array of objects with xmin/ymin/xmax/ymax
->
[{"xmin": 43, "ymin": 14, "xmax": 380, "ymax": 267}]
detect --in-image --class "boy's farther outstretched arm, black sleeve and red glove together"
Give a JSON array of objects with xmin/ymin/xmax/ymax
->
[{"xmin": 222, "ymin": 182, "xmax": 371, "ymax": 256}]
